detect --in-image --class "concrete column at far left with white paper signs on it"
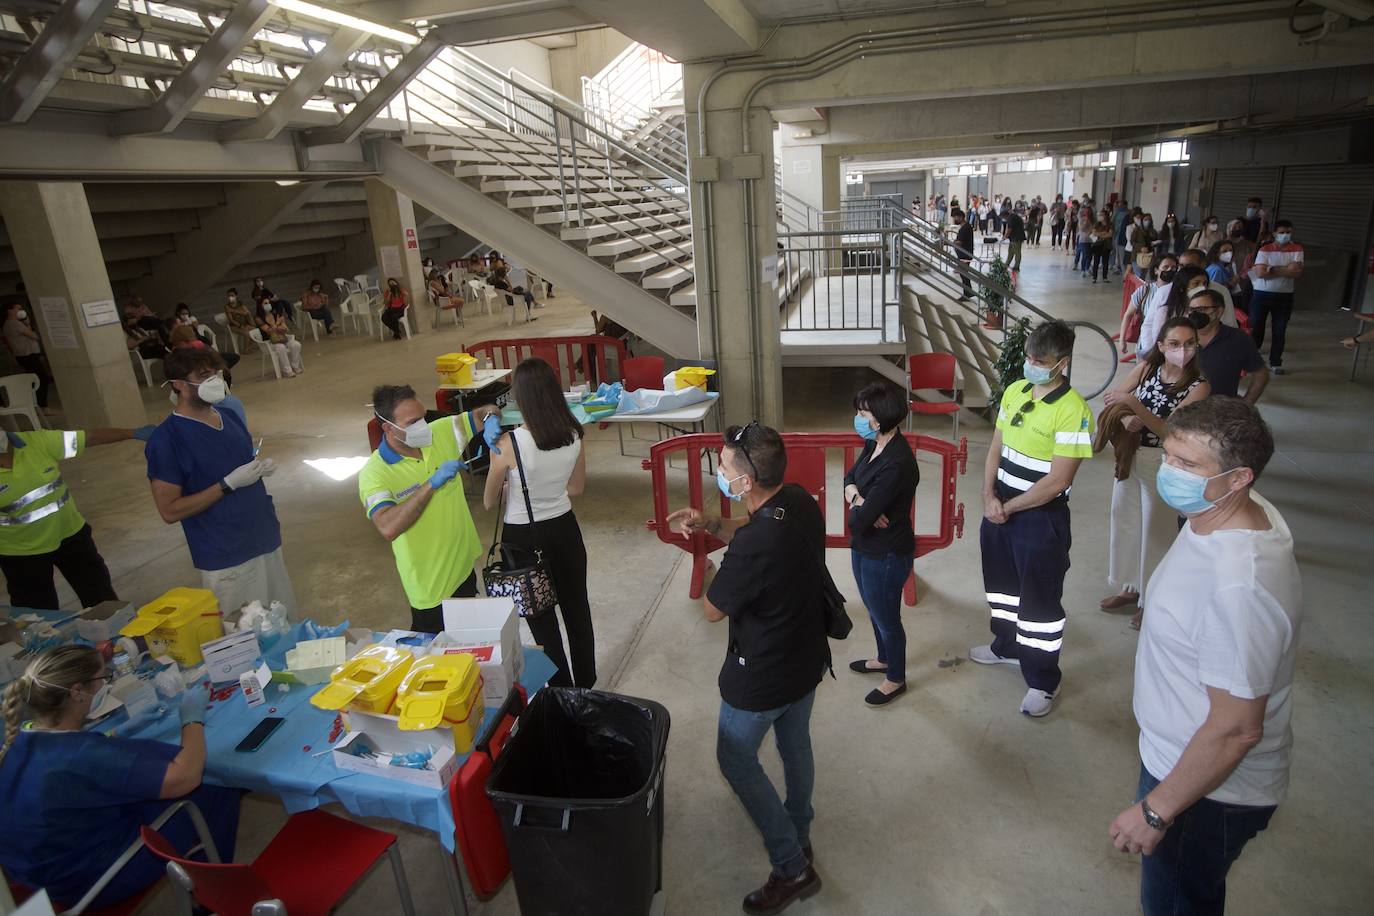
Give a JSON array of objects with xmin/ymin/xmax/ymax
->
[{"xmin": 0, "ymin": 181, "xmax": 147, "ymax": 428}]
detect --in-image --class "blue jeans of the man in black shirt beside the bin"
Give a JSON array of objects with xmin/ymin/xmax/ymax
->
[{"xmin": 716, "ymin": 691, "xmax": 816, "ymax": 878}]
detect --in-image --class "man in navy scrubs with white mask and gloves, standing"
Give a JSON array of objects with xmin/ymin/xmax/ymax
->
[{"xmin": 143, "ymin": 349, "xmax": 295, "ymax": 617}]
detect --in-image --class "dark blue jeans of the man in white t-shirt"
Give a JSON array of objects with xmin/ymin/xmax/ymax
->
[{"xmin": 1138, "ymin": 766, "xmax": 1274, "ymax": 916}]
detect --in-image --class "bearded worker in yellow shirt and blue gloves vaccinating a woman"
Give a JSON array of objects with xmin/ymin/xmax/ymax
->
[{"xmin": 357, "ymin": 385, "xmax": 502, "ymax": 633}]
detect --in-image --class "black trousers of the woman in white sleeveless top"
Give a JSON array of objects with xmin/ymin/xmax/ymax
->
[{"xmin": 502, "ymin": 512, "xmax": 596, "ymax": 687}]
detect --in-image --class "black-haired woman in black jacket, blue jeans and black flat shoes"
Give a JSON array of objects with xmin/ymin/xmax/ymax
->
[{"xmin": 845, "ymin": 382, "xmax": 921, "ymax": 706}]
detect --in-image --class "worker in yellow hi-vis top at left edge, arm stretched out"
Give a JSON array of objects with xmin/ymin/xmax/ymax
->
[{"xmin": 0, "ymin": 426, "xmax": 155, "ymax": 610}]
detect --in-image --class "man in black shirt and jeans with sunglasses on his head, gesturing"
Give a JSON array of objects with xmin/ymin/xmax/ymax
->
[{"xmin": 668, "ymin": 422, "xmax": 830, "ymax": 913}]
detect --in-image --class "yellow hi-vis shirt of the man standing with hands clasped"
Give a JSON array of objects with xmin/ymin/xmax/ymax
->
[{"xmin": 996, "ymin": 380, "xmax": 1094, "ymax": 505}]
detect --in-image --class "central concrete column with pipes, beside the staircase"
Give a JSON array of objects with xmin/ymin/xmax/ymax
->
[{"xmin": 687, "ymin": 98, "xmax": 782, "ymax": 428}]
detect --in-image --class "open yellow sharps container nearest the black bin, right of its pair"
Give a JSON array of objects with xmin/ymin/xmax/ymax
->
[{"xmin": 394, "ymin": 652, "xmax": 482, "ymax": 754}]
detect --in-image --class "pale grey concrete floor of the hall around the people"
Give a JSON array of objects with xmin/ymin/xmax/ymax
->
[{"xmin": 32, "ymin": 247, "xmax": 1374, "ymax": 916}]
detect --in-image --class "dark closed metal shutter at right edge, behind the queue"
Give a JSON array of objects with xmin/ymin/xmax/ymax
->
[{"xmin": 1274, "ymin": 165, "xmax": 1374, "ymax": 245}]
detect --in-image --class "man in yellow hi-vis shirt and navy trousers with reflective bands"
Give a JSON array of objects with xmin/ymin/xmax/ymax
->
[{"xmin": 969, "ymin": 321, "xmax": 1094, "ymax": 718}]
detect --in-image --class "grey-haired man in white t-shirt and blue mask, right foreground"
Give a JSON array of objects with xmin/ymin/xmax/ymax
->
[{"xmin": 1110, "ymin": 396, "xmax": 1303, "ymax": 916}]
